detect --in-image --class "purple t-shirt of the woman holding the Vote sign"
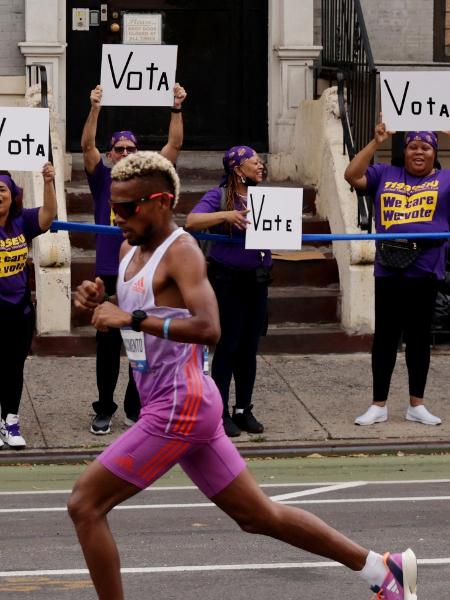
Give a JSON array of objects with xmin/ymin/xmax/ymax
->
[{"xmin": 192, "ymin": 188, "xmax": 272, "ymax": 269}]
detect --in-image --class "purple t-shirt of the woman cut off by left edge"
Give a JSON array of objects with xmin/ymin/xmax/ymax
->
[{"xmin": 0, "ymin": 208, "xmax": 43, "ymax": 304}]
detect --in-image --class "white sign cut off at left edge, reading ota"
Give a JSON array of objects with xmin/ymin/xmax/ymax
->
[{"xmin": 0, "ymin": 106, "xmax": 49, "ymax": 171}]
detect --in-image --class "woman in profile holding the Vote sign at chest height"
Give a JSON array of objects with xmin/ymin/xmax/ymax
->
[{"xmin": 186, "ymin": 146, "xmax": 272, "ymax": 437}]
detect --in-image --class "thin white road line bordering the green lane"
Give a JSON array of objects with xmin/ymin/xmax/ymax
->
[{"xmin": 0, "ymin": 479, "xmax": 450, "ymax": 496}]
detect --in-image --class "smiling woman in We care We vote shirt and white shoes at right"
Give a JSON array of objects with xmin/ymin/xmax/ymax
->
[{"xmin": 345, "ymin": 123, "xmax": 444, "ymax": 425}]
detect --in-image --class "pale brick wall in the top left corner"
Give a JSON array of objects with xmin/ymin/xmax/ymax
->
[{"xmin": 0, "ymin": 0, "xmax": 25, "ymax": 76}]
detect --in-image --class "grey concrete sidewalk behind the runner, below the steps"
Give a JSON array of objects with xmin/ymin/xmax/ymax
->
[{"xmin": 0, "ymin": 353, "xmax": 450, "ymax": 462}]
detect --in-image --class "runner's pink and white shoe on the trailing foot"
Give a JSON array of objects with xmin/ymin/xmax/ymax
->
[{"xmin": 371, "ymin": 549, "xmax": 417, "ymax": 600}]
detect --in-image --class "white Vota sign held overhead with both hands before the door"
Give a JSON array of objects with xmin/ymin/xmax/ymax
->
[{"xmin": 100, "ymin": 44, "xmax": 178, "ymax": 106}]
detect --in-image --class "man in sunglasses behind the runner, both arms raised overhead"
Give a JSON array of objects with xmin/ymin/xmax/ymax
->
[{"xmin": 81, "ymin": 84, "xmax": 186, "ymax": 435}]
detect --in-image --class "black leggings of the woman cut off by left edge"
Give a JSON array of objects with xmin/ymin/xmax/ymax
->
[{"xmin": 0, "ymin": 304, "xmax": 35, "ymax": 419}]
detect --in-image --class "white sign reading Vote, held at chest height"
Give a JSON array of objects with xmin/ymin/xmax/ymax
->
[{"xmin": 245, "ymin": 186, "xmax": 303, "ymax": 250}]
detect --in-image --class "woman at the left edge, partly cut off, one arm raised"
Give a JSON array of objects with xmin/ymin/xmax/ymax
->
[{"xmin": 0, "ymin": 163, "xmax": 56, "ymax": 449}]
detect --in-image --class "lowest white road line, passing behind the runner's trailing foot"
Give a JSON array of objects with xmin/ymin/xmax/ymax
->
[{"xmin": 0, "ymin": 558, "xmax": 450, "ymax": 577}]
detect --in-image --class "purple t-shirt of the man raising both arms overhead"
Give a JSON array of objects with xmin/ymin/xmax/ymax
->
[{"xmin": 86, "ymin": 160, "xmax": 123, "ymax": 275}]
